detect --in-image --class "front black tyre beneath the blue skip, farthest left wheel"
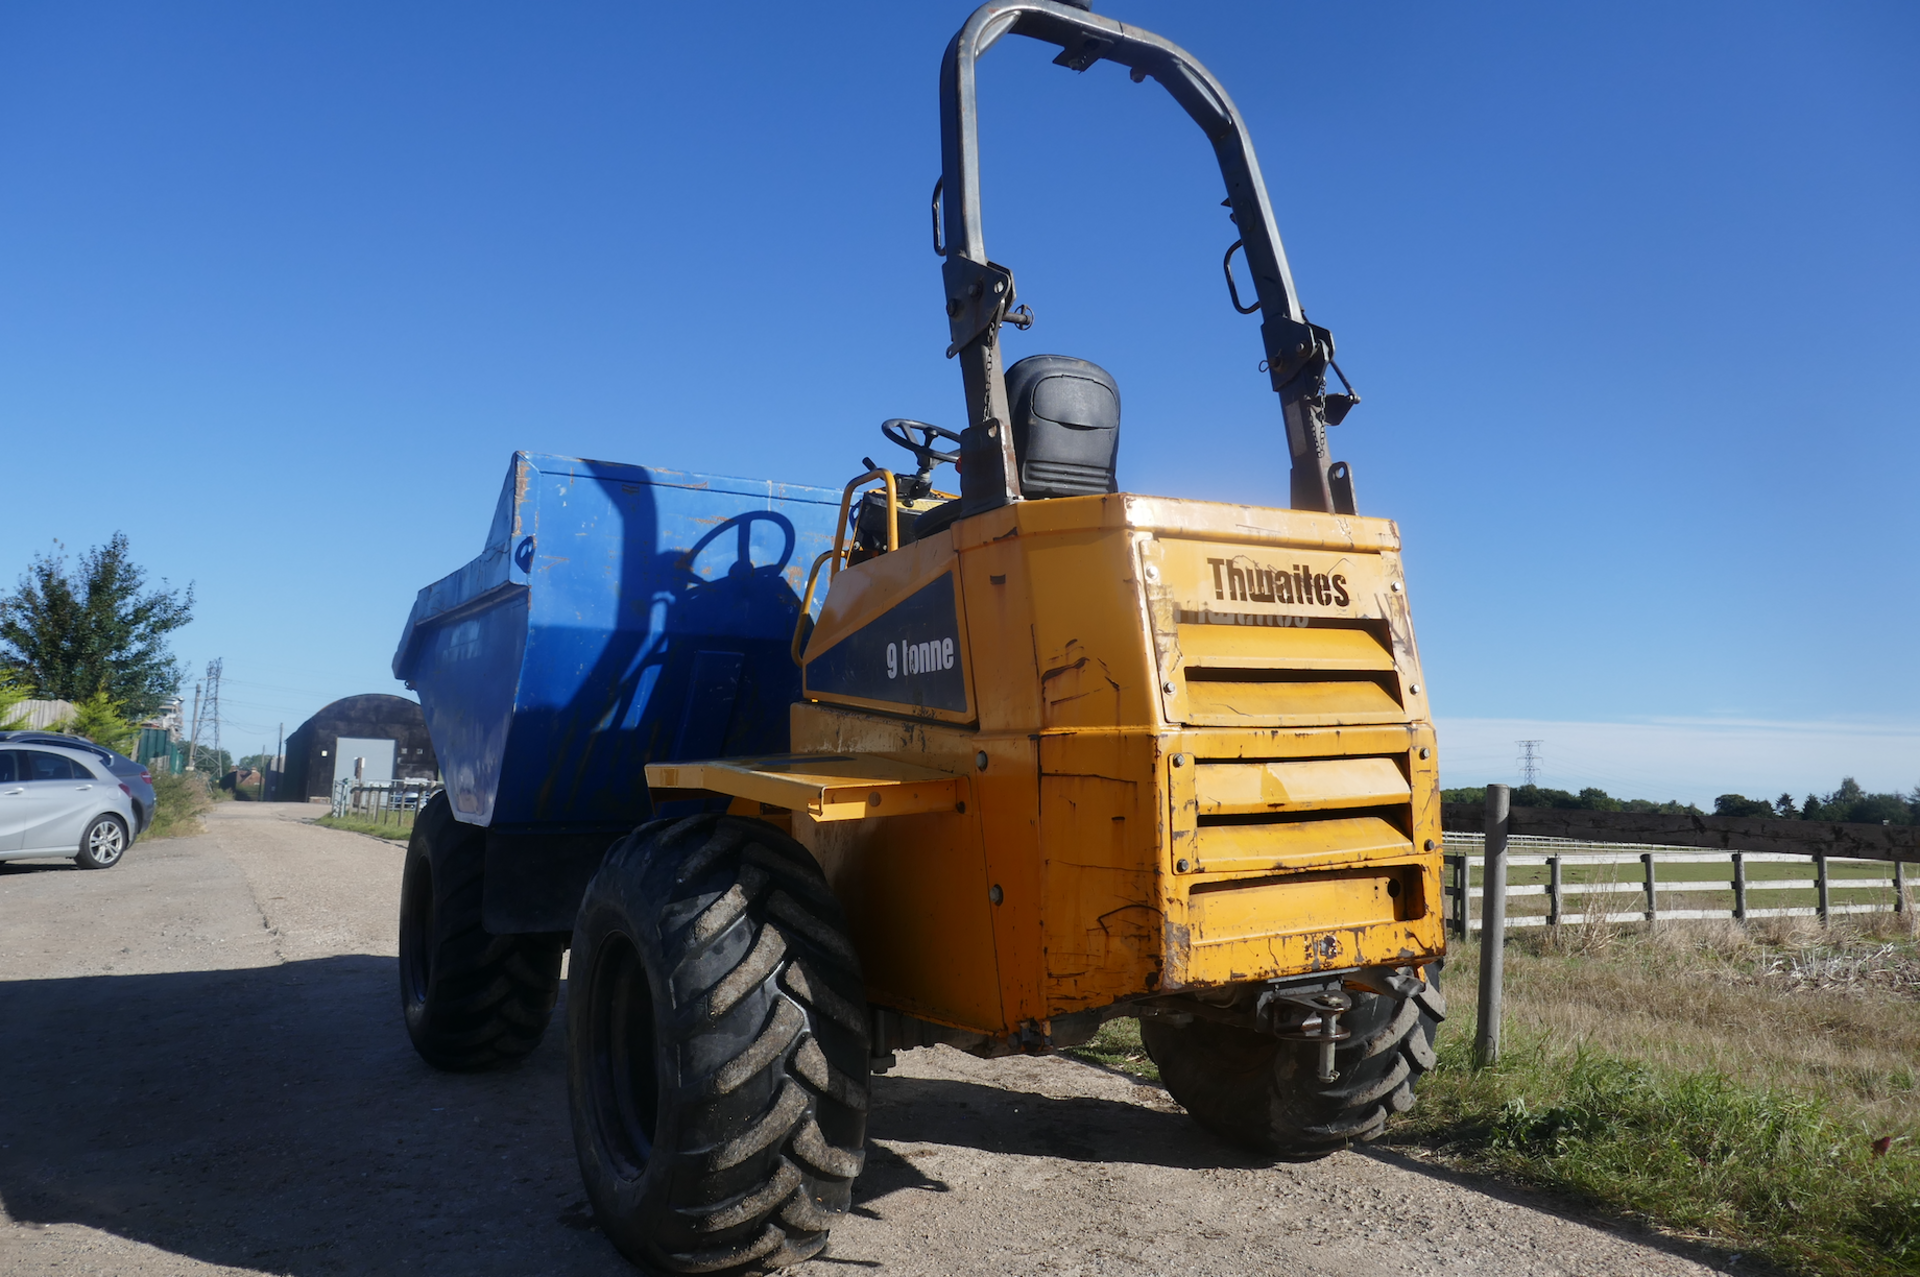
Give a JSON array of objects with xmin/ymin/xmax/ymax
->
[{"xmin": 399, "ymin": 793, "xmax": 566, "ymax": 1073}]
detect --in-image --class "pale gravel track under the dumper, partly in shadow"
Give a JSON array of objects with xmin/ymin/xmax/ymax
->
[{"xmin": 0, "ymin": 803, "xmax": 1741, "ymax": 1277}]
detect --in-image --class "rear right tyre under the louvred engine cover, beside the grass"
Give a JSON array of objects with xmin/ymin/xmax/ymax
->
[{"xmin": 1140, "ymin": 964, "xmax": 1446, "ymax": 1162}]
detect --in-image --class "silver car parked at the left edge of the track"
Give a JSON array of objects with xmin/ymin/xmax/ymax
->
[{"xmin": 0, "ymin": 739, "xmax": 138, "ymax": 870}]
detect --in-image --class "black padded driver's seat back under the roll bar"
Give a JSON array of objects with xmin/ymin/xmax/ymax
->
[{"xmin": 1006, "ymin": 355, "xmax": 1119, "ymax": 497}]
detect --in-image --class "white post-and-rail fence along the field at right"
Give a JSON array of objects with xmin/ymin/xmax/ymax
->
[{"xmin": 1442, "ymin": 833, "xmax": 1914, "ymax": 935}]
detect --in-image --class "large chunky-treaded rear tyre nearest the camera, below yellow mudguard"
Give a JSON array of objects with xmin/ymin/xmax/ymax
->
[{"xmin": 566, "ymin": 814, "xmax": 868, "ymax": 1275}]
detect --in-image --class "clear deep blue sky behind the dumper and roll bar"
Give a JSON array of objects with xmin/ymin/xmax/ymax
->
[{"xmin": 0, "ymin": 0, "xmax": 1920, "ymax": 801}]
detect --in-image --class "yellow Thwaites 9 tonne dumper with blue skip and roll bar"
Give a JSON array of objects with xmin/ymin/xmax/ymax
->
[{"xmin": 396, "ymin": 0, "xmax": 1446, "ymax": 1273}]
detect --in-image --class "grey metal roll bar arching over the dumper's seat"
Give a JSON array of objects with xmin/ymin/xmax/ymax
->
[{"xmin": 933, "ymin": 0, "xmax": 1356, "ymax": 515}]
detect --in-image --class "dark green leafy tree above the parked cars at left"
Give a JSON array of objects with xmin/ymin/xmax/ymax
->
[{"xmin": 0, "ymin": 532, "xmax": 194, "ymax": 722}]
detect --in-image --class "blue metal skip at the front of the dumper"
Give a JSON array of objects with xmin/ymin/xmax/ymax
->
[{"xmin": 394, "ymin": 453, "xmax": 839, "ymax": 828}]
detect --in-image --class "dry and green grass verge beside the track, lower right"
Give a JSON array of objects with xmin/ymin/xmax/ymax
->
[{"xmin": 1386, "ymin": 920, "xmax": 1920, "ymax": 1277}]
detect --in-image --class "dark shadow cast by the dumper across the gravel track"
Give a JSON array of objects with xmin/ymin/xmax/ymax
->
[{"xmin": 0, "ymin": 956, "xmax": 1274, "ymax": 1277}]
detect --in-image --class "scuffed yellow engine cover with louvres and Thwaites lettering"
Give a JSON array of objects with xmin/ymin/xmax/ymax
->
[{"xmin": 793, "ymin": 494, "xmax": 1446, "ymax": 1033}]
